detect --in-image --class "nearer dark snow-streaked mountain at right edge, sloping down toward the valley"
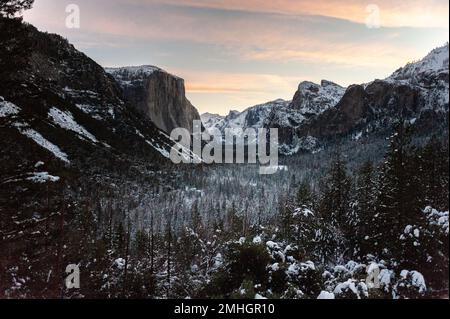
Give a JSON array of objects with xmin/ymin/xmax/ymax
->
[{"xmin": 295, "ymin": 44, "xmax": 449, "ymax": 140}]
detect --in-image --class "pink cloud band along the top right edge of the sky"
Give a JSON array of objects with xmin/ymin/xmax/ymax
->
[{"xmin": 147, "ymin": 0, "xmax": 449, "ymax": 28}]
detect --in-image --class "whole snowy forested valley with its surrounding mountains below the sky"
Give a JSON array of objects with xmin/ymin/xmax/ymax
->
[{"xmin": 0, "ymin": 9, "xmax": 449, "ymax": 299}]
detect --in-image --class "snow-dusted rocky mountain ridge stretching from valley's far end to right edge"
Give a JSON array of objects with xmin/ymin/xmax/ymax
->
[{"xmin": 203, "ymin": 43, "xmax": 448, "ymax": 155}]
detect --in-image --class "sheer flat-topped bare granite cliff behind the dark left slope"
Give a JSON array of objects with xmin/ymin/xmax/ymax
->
[{"xmin": 106, "ymin": 66, "xmax": 200, "ymax": 133}]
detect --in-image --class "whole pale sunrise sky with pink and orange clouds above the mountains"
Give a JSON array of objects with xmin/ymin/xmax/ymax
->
[{"xmin": 25, "ymin": 0, "xmax": 449, "ymax": 114}]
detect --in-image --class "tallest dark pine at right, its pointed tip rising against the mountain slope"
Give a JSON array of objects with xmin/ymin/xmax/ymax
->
[{"xmin": 370, "ymin": 121, "xmax": 424, "ymax": 259}]
